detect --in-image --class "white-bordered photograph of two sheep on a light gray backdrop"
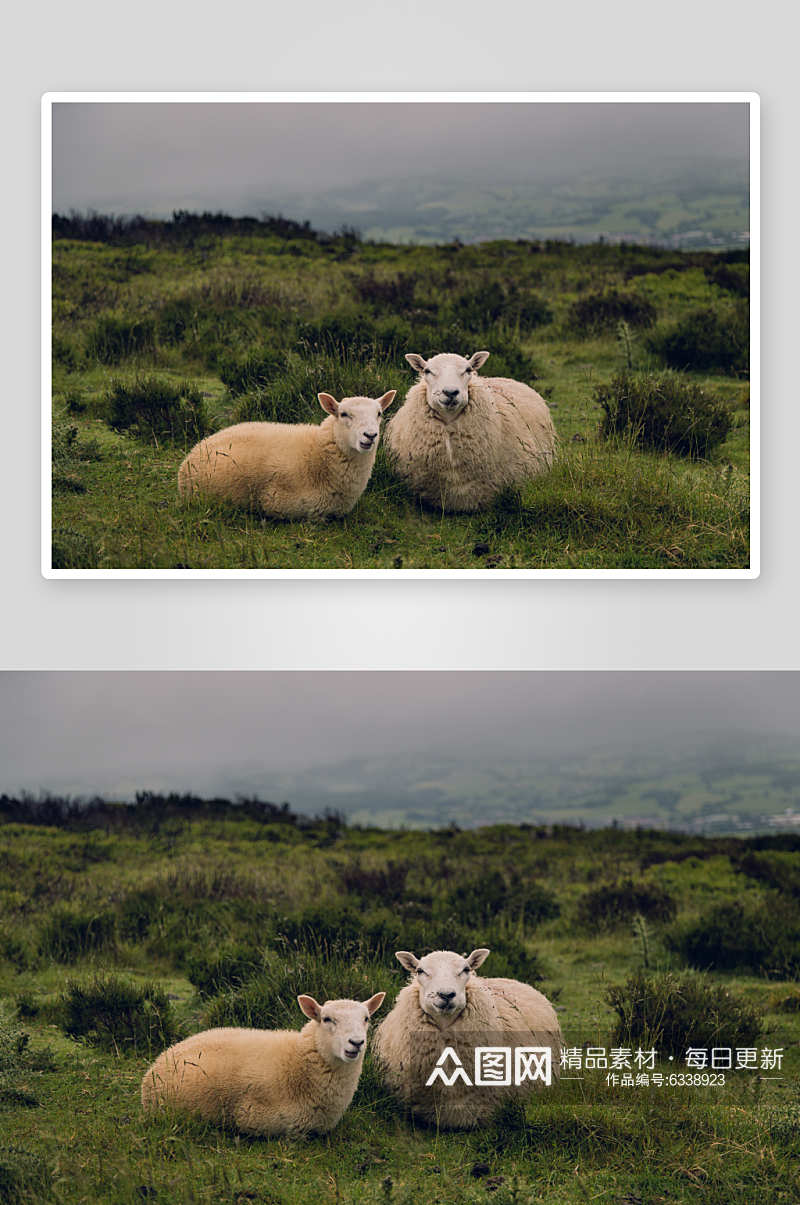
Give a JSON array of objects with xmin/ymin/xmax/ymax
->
[{"xmin": 42, "ymin": 93, "xmax": 760, "ymax": 578}]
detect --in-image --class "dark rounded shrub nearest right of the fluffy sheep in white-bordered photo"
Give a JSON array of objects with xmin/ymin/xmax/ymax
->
[{"xmin": 594, "ymin": 372, "xmax": 733, "ymax": 457}]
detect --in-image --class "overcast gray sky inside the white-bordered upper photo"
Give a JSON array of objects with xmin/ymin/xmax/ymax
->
[{"xmin": 53, "ymin": 100, "xmax": 749, "ymax": 216}]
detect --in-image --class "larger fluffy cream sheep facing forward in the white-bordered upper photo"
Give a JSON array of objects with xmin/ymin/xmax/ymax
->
[{"xmin": 387, "ymin": 352, "xmax": 555, "ymax": 511}]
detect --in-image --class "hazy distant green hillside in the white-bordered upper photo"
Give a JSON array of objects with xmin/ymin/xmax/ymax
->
[{"xmin": 263, "ymin": 159, "xmax": 749, "ymax": 247}]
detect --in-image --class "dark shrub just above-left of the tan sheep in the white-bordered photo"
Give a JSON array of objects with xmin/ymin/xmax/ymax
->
[{"xmin": 106, "ymin": 376, "xmax": 211, "ymax": 442}]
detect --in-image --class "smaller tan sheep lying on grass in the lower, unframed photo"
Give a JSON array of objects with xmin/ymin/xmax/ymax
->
[{"xmin": 142, "ymin": 992, "xmax": 386, "ymax": 1138}]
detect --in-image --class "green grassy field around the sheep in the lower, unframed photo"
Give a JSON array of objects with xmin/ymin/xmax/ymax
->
[{"xmin": 0, "ymin": 797, "xmax": 800, "ymax": 1205}]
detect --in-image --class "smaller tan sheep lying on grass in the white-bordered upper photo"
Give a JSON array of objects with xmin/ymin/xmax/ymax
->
[{"xmin": 178, "ymin": 389, "xmax": 396, "ymax": 521}]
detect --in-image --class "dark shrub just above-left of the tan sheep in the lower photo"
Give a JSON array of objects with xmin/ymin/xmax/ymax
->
[{"xmin": 59, "ymin": 975, "xmax": 178, "ymax": 1056}]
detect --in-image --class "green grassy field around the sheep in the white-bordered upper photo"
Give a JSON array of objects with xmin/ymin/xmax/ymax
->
[{"xmin": 52, "ymin": 219, "xmax": 749, "ymax": 572}]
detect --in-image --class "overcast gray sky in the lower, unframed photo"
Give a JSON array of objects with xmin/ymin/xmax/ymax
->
[{"xmin": 0, "ymin": 671, "xmax": 800, "ymax": 798}]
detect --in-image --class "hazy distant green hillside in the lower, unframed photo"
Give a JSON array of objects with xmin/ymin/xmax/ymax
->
[{"xmin": 249, "ymin": 735, "xmax": 800, "ymax": 831}]
